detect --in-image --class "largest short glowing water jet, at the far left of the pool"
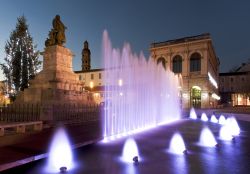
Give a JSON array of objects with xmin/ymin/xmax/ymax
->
[{"xmin": 47, "ymin": 128, "xmax": 73, "ymax": 172}]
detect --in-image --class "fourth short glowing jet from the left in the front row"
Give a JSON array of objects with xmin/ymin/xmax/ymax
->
[{"xmin": 199, "ymin": 127, "xmax": 217, "ymax": 147}]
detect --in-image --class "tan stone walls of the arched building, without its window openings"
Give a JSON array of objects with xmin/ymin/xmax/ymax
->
[{"xmin": 150, "ymin": 35, "xmax": 219, "ymax": 108}]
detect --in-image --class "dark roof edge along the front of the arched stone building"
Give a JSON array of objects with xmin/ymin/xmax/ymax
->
[{"xmin": 151, "ymin": 33, "xmax": 211, "ymax": 48}]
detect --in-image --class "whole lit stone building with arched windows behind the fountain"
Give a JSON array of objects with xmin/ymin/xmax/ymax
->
[{"xmin": 150, "ymin": 33, "xmax": 220, "ymax": 108}]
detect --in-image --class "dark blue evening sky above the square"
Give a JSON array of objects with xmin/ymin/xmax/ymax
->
[{"xmin": 0, "ymin": 0, "xmax": 250, "ymax": 79}]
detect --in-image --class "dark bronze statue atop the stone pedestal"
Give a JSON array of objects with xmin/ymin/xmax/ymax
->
[{"xmin": 45, "ymin": 15, "xmax": 67, "ymax": 47}]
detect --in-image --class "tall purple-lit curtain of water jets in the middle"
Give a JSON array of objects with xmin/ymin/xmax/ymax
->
[{"xmin": 103, "ymin": 31, "xmax": 180, "ymax": 137}]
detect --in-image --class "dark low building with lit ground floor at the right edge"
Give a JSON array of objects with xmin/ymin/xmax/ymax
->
[{"xmin": 219, "ymin": 63, "xmax": 250, "ymax": 106}]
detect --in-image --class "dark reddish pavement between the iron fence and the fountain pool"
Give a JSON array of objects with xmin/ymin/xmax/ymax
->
[{"xmin": 0, "ymin": 121, "xmax": 102, "ymax": 173}]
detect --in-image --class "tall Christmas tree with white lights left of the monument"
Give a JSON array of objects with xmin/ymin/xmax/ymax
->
[{"xmin": 0, "ymin": 16, "xmax": 41, "ymax": 100}]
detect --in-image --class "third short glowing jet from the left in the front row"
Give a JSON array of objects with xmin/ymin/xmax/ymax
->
[{"xmin": 168, "ymin": 133, "xmax": 186, "ymax": 155}]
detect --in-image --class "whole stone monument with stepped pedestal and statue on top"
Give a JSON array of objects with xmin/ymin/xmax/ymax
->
[{"xmin": 15, "ymin": 15, "xmax": 93, "ymax": 119}]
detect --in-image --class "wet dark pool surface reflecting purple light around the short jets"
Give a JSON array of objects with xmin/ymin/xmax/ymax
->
[{"xmin": 5, "ymin": 120, "xmax": 250, "ymax": 174}]
